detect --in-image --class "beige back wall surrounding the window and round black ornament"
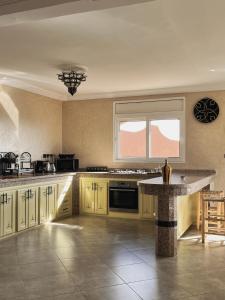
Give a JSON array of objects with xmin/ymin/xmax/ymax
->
[{"xmin": 63, "ymin": 92, "xmax": 225, "ymax": 189}]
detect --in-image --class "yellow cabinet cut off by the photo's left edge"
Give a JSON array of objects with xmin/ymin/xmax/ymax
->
[{"xmin": 0, "ymin": 191, "xmax": 16, "ymax": 236}]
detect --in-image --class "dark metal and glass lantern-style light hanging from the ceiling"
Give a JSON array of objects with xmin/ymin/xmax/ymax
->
[{"xmin": 58, "ymin": 71, "xmax": 87, "ymax": 96}]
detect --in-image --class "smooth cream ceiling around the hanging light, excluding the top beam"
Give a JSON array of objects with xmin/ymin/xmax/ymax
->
[{"xmin": 0, "ymin": 0, "xmax": 225, "ymax": 100}]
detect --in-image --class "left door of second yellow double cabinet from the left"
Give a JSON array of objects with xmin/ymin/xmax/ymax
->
[{"xmin": 17, "ymin": 189, "xmax": 28, "ymax": 231}]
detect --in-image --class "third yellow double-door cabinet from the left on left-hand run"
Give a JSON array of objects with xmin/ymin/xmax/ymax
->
[{"xmin": 40, "ymin": 184, "xmax": 57, "ymax": 223}]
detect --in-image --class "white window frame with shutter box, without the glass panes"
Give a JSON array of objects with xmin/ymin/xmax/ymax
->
[{"xmin": 113, "ymin": 98, "xmax": 186, "ymax": 163}]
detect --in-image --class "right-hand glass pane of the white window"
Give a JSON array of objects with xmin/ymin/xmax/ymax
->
[{"xmin": 149, "ymin": 120, "xmax": 180, "ymax": 157}]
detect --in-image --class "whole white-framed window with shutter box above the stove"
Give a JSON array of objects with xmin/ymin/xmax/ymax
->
[{"xmin": 114, "ymin": 98, "xmax": 185, "ymax": 162}]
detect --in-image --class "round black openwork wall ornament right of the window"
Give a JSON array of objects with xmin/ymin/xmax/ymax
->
[{"xmin": 194, "ymin": 97, "xmax": 219, "ymax": 123}]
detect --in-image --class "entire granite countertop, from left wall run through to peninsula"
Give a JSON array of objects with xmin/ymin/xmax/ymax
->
[{"xmin": 0, "ymin": 170, "xmax": 216, "ymax": 190}]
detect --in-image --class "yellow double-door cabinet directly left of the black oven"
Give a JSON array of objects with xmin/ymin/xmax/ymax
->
[{"xmin": 80, "ymin": 179, "xmax": 108, "ymax": 215}]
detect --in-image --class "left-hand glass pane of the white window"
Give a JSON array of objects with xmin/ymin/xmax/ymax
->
[{"xmin": 118, "ymin": 121, "xmax": 146, "ymax": 158}]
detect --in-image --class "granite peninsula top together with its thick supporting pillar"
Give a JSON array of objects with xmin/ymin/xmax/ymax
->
[{"xmin": 139, "ymin": 170, "xmax": 216, "ymax": 257}]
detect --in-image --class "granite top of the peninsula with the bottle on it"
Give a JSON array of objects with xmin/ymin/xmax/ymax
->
[{"xmin": 138, "ymin": 169, "xmax": 216, "ymax": 195}]
